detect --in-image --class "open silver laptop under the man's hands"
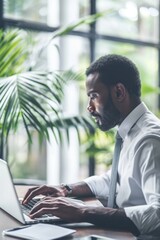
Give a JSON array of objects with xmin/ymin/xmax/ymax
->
[{"xmin": 0, "ymin": 159, "xmax": 64, "ymax": 224}]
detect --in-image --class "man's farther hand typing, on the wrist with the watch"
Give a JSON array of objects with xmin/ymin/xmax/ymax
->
[{"xmin": 22, "ymin": 185, "xmax": 65, "ymax": 204}]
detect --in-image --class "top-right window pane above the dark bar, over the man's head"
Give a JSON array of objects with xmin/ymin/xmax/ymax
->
[{"xmin": 97, "ymin": 0, "xmax": 159, "ymax": 42}]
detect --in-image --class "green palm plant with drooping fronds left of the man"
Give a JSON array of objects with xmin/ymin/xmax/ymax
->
[{"xmin": 0, "ymin": 13, "xmax": 107, "ymax": 158}]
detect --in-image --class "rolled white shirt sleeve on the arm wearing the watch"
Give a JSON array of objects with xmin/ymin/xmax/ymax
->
[{"xmin": 84, "ymin": 170, "xmax": 111, "ymax": 199}]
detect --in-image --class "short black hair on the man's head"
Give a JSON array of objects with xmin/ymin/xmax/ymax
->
[{"xmin": 86, "ymin": 54, "xmax": 141, "ymax": 97}]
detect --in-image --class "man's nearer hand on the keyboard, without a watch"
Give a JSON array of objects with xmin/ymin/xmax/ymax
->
[{"xmin": 30, "ymin": 197, "xmax": 86, "ymax": 222}]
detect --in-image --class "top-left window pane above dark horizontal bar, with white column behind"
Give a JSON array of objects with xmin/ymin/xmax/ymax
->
[{"xmin": 4, "ymin": 0, "xmax": 89, "ymax": 29}]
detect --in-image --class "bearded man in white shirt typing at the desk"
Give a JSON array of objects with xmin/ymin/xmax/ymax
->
[{"xmin": 23, "ymin": 55, "xmax": 160, "ymax": 235}]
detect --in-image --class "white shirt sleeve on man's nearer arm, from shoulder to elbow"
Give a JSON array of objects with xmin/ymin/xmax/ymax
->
[{"xmin": 124, "ymin": 136, "xmax": 160, "ymax": 234}]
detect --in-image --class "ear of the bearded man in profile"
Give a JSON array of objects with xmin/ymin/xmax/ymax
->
[{"xmin": 112, "ymin": 83, "xmax": 127, "ymax": 102}]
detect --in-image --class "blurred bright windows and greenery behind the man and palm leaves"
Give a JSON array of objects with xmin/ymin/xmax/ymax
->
[{"xmin": 0, "ymin": 0, "xmax": 160, "ymax": 184}]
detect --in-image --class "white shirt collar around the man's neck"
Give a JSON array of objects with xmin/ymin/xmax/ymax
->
[{"xmin": 118, "ymin": 102, "xmax": 148, "ymax": 140}]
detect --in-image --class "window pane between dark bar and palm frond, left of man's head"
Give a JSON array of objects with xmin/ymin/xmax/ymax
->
[{"xmin": 26, "ymin": 31, "xmax": 90, "ymax": 71}]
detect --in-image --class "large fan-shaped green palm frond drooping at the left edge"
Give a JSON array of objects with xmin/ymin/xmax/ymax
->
[{"xmin": 0, "ymin": 72, "xmax": 64, "ymax": 140}]
